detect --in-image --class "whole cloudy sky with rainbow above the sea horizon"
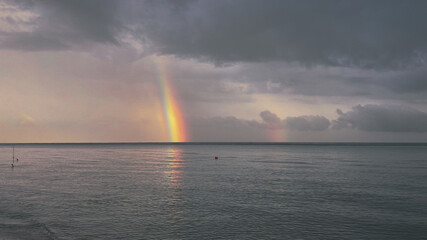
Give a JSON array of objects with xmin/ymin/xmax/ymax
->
[{"xmin": 0, "ymin": 0, "xmax": 427, "ymax": 143}]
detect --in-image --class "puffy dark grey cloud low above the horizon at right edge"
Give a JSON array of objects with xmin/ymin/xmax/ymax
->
[{"xmin": 332, "ymin": 105, "xmax": 427, "ymax": 132}]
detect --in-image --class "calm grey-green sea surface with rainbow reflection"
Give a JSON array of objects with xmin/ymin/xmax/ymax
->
[{"xmin": 0, "ymin": 144, "xmax": 427, "ymax": 239}]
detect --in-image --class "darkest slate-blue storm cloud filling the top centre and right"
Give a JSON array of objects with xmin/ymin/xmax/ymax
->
[{"xmin": 141, "ymin": 0, "xmax": 427, "ymax": 67}]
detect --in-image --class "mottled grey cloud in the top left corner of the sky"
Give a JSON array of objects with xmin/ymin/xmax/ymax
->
[{"xmin": 0, "ymin": 0, "xmax": 122, "ymax": 51}]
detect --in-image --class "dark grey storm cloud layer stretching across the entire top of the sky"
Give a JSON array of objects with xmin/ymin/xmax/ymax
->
[{"xmin": 3, "ymin": 0, "xmax": 427, "ymax": 67}]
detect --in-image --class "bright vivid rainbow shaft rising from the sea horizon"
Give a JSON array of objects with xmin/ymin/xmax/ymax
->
[{"xmin": 154, "ymin": 57, "xmax": 187, "ymax": 142}]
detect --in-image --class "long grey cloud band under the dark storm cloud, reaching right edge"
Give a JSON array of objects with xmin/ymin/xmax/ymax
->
[{"xmin": 181, "ymin": 62, "xmax": 427, "ymax": 102}]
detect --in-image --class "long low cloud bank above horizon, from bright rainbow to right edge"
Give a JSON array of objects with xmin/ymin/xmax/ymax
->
[{"xmin": 193, "ymin": 104, "xmax": 427, "ymax": 141}]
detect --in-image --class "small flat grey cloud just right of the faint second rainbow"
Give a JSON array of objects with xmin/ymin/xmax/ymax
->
[{"xmin": 284, "ymin": 116, "xmax": 331, "ymax": 131}]
